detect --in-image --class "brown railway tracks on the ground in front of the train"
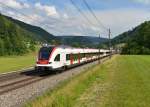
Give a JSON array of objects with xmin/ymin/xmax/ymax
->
[{"xmin": 0, "ymin": 55, "xmax": 110, "ymax": 95}]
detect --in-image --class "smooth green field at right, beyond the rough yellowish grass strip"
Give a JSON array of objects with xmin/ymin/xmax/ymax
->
[{"xmin": 104, "ymin": 56, "xmax": 150, "ymax": 107}]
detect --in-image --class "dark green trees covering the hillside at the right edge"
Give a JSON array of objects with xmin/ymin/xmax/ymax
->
[{"xmin": 113, "ymin": 21, "xmax": 150, "ymax": 54}]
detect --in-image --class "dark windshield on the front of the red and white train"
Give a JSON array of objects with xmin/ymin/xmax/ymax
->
[{"xmin": 39, "ymin": 47, "xmax": 53, "ymax": 60}]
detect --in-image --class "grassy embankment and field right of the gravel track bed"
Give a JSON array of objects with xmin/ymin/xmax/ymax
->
[{"xmin": 26, "ymin": 56, "xmax": 150, "ymax": 107}]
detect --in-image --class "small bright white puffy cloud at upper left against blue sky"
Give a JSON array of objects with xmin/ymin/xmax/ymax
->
[{"xmin": 35, "ymin": 3, "xmax": 58, "ymax": 16}]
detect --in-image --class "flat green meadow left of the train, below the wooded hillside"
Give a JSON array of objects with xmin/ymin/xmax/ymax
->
[{"xmin": 0, "ymin": 53, "xmax": 36, "ymax": 73}]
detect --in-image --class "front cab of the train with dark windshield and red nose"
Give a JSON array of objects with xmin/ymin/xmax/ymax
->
[{"xmin": 35, "ymin": 47, "xmax": 64, "ymax": 71}]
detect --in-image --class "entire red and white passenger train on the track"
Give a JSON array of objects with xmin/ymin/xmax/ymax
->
[{"xmin": 35, "ymin": 46, "xmax": 110, "ymax": 70}]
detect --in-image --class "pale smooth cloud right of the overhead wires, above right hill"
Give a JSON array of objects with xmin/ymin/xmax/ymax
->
[{"xmin": 94, "ymin": 8, "xmax": 150, "ymax": 36}]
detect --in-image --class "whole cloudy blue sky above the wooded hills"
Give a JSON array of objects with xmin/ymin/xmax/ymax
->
[{"xmin": 0, "ymin": 0, "xmax": 150, "ymax": 38}]
